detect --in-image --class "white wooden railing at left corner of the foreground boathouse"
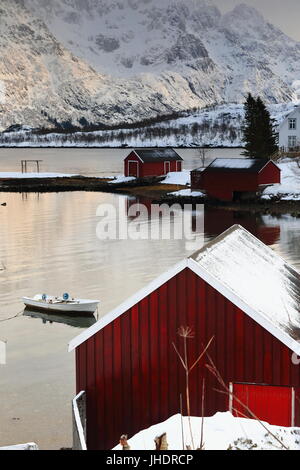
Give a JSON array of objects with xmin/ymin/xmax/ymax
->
[{"xmin": 72, "ymin": 391, "xmax": 87, "ymax": 450}]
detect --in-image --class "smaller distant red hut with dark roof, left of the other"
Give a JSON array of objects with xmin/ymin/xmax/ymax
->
[{"xmin": 124, "ymin": 148, "xmax": 183, "ymax": 178}]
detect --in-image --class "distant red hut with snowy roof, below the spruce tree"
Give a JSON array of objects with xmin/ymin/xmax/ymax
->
[{"xmin": 191, "ymin": 158, "xmax": 281, "ymax": 201}]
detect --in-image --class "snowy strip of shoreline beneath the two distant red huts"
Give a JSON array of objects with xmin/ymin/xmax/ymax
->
[{"xmin": 0, "ymin": 159, "xmax": 300, "ymax": 208}]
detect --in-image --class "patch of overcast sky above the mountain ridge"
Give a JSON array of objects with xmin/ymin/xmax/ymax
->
[{"xmin": 215, "ymin": 0, "xmax": 300, "ymax": 41}]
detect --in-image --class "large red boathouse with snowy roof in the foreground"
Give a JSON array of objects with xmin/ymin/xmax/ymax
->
[{"xmin": 69, "ymin": 225, "xmax": 300, "ymax": 449}]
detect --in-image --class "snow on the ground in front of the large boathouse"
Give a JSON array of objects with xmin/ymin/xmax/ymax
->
[{"xmin": 113, "ymin": 411, "xmax": 300, "ymax": 450}]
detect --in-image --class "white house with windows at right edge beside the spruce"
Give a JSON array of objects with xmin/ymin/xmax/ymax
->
[{"xmin": 279, "ymin": 106, "xmax": 300, "ymax": 150}]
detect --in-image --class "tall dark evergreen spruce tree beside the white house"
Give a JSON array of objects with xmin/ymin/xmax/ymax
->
[{"xmin": 243, "ymin": 93, "xmax": 278, "ymax": 158}]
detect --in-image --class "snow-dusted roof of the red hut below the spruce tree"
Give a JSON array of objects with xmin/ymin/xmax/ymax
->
[{"xmin": 193, "ymin": 158, "xmax": 274, "ymax": 173}]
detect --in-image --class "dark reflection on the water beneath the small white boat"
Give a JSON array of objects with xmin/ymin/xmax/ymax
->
[{"xmin": 23, "ymin": 308, "xmax": 97, "ymax": 328}]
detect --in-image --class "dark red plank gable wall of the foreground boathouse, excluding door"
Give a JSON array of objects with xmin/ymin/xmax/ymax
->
[{"xmin": 76, "ymin": 269, "xmax": 300, "ymax": 449}]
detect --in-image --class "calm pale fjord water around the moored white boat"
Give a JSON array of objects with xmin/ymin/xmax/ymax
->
[{"xmin": 0, "ymin": 149, "xmax": 300, "ymax": 449}]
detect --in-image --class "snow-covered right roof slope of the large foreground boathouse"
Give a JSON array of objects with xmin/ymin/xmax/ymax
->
[{"xmin": 191, "ymin": 225, "xmax": 300, "ymax": 346}]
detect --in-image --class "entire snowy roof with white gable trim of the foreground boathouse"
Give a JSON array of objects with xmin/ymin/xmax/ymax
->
[{"xmin": 69, "ymin": 225, "xmax": 300, "ymax": 354}]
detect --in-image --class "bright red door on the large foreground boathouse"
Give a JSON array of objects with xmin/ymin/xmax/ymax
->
[{"xmin": 229, "ymin": 384, "xmax": 295, "ymax": 426}]
